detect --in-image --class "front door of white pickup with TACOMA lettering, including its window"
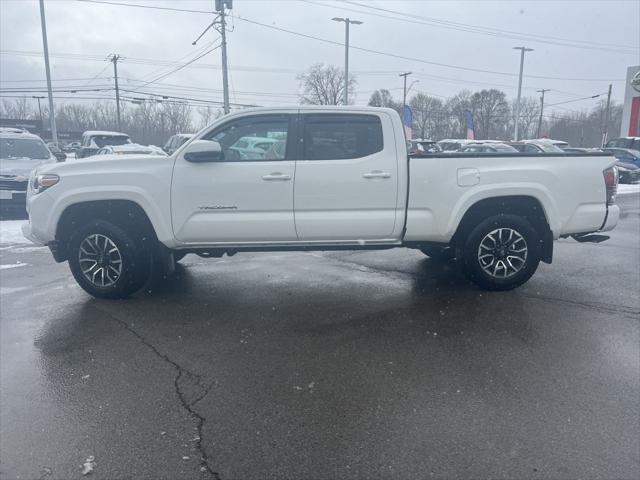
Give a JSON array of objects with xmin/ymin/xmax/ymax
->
[{"xmin": 171, "ymin": 113, "xmax": 297, "ymax": 244}]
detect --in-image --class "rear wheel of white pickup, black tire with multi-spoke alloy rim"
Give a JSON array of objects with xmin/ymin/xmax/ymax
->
[{"xmin": 461, "ymin": 215, "xmax": 540, "ymax": 290}]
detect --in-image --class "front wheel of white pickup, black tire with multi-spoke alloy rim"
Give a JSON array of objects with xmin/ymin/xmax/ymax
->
[{"xmin": 69, "ymin": 220, "xmax": 152, "ymax": 298}]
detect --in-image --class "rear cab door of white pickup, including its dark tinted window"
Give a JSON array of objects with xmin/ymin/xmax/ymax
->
[{"xmin": 294, "ymin": 113, "xmax": 398, "ymax": 241}]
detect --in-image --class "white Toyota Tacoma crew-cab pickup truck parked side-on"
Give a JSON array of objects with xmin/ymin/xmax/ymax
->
[{"xmin": 23, "ymin": 106, "xmax": 619, "ymax": 298}]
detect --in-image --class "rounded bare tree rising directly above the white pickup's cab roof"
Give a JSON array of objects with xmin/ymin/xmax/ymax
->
[{"xmin": 297, "ymin": 63, "xmax": 356, "ymax": 105}]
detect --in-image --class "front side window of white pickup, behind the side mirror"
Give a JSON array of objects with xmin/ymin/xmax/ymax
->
[{"xmin": 203, "ymin": 115, "xmax": 289, "ymax": 162}]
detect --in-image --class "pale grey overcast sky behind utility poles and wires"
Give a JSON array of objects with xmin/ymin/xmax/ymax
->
[{"xmin": 0, "ymin": 0, "xmax": 640, "ymax": 110}]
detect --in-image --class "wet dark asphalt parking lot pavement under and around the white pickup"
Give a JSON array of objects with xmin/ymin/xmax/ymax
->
[{"xmin": 0, "ymin": 195, "xmax": 640, "ymax": 479}]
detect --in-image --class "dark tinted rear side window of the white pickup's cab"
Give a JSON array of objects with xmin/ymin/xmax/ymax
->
[{"xmin": 302, "ymin": 113, "xmax": 384, "ymax": 160}]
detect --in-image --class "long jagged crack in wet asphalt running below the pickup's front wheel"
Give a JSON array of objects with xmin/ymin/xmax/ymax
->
[{"xmin": 94, "ymin": 305, "xmax": 220, "ymax": 480}]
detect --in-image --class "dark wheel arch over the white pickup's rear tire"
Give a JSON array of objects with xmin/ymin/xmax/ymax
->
[{"xmin": 451, "ymin": 195, "xmax": 553, "ymax": 263}]
